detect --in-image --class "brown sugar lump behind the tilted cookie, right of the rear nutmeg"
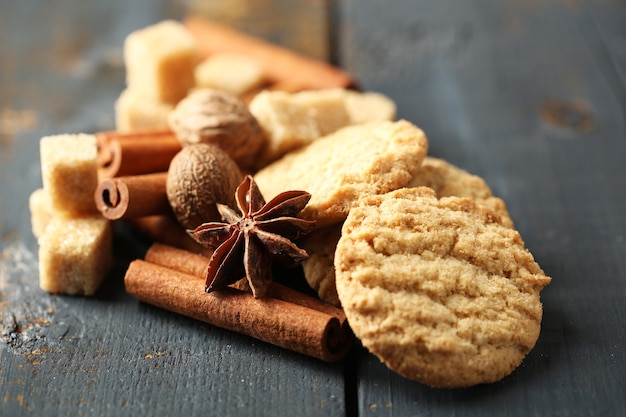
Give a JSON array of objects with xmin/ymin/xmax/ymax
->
[{"xmin": 249, "ymin": 89, "xmax": 350, "ymax": 166}]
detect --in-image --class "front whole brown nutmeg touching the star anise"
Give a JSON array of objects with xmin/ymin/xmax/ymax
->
[{"xmin": 165, "ymin": 143, "xmax": 243, "ymax": 229}]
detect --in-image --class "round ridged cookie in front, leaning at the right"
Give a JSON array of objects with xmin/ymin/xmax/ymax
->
[{"xmin": 335, "ymin": 187, "xmax": 550, "ymax": 388}]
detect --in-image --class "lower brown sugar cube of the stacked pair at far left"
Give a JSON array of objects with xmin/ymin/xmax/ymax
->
[{"xmin": 39, "ymin": 216, "xmax": 113, "ymax": 295}]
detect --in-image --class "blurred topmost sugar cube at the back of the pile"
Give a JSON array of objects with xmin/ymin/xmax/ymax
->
[{"xmin": 124, "ymin": 20, "xmax": 198, "ymax": 104}]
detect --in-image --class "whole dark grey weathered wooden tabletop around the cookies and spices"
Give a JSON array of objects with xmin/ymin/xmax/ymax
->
[{"xmin": 0, "ymin": 0, "xmax": 626, "ymax": 417}]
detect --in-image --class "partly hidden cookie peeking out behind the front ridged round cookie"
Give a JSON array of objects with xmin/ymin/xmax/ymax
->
[{"xmin": 406, "ymin": 156, "xmax": 513, "ymax": 228}]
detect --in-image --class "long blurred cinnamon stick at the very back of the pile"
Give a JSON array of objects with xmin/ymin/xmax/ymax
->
[{"xmin": 183, "ymin": 16, "xmax": 355, "ymax": 91}]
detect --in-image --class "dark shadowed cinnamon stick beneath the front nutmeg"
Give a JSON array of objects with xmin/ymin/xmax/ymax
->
[{"xmin": 126, "ymin": 214, "xmax": 213, "ymax": 256}]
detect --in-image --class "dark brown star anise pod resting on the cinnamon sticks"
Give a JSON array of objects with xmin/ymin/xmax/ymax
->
[{"xmin": 189, "ymin": 175, "xmax": 315, "ymax": 298}]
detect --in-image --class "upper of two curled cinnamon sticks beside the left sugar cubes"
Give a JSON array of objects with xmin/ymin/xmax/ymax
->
[{"xmin": 96, "ymin": 130, "xmax": 181, "ymax": 178}]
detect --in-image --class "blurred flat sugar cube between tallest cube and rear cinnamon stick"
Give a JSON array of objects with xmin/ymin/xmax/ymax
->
[{"xmin": 195, "ymin": 52, "xmax": 263, "ymax": 96}]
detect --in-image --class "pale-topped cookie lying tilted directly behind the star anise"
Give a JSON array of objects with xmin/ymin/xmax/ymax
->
[{"xmin": 254, "ymin": 120, "xmax": 428, "ymax": 227}]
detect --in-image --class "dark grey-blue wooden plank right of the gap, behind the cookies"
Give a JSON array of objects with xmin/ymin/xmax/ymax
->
[{"xmin": 339, "ymin": 0, "xmax": 626, "ymax": 416}]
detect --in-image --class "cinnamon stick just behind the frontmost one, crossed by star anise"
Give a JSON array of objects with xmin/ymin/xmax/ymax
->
[{"xmin": 145, "ymin": 242, "xmax": 347, "ymax": 320}]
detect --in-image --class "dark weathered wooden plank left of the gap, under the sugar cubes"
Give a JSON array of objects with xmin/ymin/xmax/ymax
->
[{"xmin": 0, "ymin": 0, "xmax": 345, "ymax": 416}]
